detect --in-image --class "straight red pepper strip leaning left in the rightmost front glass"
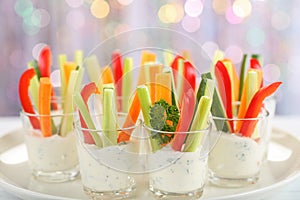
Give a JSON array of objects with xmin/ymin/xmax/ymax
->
[{"xmin": 215, "ymin": 61, "xmax": 234, "ymax": 131}]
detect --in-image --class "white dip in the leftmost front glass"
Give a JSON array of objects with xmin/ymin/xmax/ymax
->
[{"xmin": 25, "ymin": 132, "xmax": 78, "ymax": 172}]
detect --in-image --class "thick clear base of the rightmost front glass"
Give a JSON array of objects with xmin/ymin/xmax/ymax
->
[{"xmin": 208, "ymin": 171, "xmax": 259, "ymax": 188}]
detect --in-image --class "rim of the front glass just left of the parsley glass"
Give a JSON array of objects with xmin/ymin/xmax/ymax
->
[{"xmin": 74, "ymin": 112, "xmax": 142, "ymax": 132}]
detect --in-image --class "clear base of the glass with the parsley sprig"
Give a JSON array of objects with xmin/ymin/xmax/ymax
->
[{"xmin": 149, "ymin": 185, "xmax": 203, "ymax": 199}]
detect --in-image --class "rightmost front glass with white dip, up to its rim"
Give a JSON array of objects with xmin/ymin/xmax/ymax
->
[{"xmin": 208, "ymin": 105, "xmax": 269, "ymax": 187}]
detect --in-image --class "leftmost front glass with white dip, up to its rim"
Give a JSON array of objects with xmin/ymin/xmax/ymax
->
[{"xmin": 20, "ymin": 104, "xmax": 79, "ymax": 182}]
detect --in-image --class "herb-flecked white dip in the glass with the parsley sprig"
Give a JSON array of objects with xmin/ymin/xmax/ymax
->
[{"xmin": 149, "ymin": 147, "xmax": 207, "ymax": 193}]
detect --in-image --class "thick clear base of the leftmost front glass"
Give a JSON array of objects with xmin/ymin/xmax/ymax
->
[{"xmin": 32, "ymin": 165, "xmax": 79, "ymax": 183}]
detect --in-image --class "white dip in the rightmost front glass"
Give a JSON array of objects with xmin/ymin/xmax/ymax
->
[{"xmin": 208, "ymin": 132, "xmax": 265, "ymax": 178}]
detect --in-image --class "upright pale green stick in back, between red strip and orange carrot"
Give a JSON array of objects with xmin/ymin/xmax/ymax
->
[{"xmin": 122, "ymin": 57, "xmax": 133, "ymax": 113}]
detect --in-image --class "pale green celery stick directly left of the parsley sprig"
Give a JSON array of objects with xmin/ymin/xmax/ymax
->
[{"xmin": 137, "ymin": 85, "xmax": 160, "ymax": 152}]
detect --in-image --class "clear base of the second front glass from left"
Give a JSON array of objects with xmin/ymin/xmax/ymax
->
[{"xmin": 83, "ymin": 185, "xmax": 136, "ymax": 200}]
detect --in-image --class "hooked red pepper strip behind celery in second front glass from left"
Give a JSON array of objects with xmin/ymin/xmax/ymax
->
[{"xmin": 79, "ymin": 82, "xmax": 99, "ymax": 144}]
